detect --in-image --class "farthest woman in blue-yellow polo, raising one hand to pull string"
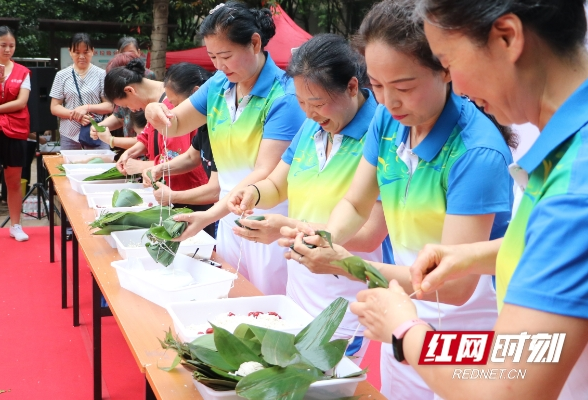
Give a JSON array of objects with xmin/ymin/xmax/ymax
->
[{"xmin": 145, "ymin": 1, "xmax": 304, "ymax": 295}]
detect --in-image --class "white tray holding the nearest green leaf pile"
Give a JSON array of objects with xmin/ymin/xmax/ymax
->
[{"xmin": 192, "ymin": 357, "xmax": 367, "ymax": 400}]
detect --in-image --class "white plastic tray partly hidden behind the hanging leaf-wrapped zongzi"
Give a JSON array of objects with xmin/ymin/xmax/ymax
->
[{"xmin": 111, "ymin": 229, "xmax": 216, "ymax": 260}]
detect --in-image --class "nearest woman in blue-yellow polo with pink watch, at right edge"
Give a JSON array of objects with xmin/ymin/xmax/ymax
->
[{"xmin": 351, "ymin": 0, "xmax": 588, "ymax": 400}]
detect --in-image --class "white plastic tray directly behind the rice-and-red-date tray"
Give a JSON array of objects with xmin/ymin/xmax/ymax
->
[{"xmin": 111, "ymin": 254, "xmax": 236, "ymax": 307}]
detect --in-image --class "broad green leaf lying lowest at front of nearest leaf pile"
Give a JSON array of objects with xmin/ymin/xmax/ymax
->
[{"xmin": 236, "ymin": 364, "xmax": 323, "ymax": 400}]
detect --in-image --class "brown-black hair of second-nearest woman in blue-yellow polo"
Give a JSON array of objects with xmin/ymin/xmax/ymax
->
[{"xmin": 353, "ymin": 0, "xmax": 518, "ymax": 149}]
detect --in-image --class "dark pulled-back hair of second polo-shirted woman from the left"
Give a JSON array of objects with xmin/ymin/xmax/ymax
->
[{"xmin": 286, "ymin": 33, "xmax": 368, "ymax": 96}]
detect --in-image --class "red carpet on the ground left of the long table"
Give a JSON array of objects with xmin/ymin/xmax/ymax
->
[{"xmin": 0, "ymin": 227, "xmax": 145, "ymax": 400}]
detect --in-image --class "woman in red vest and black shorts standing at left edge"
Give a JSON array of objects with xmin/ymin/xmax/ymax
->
[{"xmin": 0, "ymin": 26, "xmax": 31, "ymax": 242}]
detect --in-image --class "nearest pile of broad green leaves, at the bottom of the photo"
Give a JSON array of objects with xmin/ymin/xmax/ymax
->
[{"xmin": 160, "ymin": 298, "xmax": 366, "ymax": 400}]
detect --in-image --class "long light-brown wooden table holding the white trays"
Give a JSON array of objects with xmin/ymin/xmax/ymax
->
[{"xmin": 45, "ymin": 158, "xmax": 384, "ymax": 400}]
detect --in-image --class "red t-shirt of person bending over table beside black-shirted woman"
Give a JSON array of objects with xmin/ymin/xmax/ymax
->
[{"xmin": 137, "ymin": 98, "xmax": 208, "ymax": 191}]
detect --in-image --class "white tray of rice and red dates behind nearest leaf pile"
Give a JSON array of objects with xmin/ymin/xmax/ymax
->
[{"xmin": 167, "ymin": 295, "xmax": 313, "ymax": 342}]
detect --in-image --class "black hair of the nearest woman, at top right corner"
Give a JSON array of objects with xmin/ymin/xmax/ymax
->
[{"xmin": 417, "ymin": 0, "xmax": 586, "ymax": 55}]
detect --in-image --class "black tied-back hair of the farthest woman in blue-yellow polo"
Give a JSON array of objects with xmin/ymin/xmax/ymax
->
[{"xmin": 200, "ymin": 1, "xmax": 276, "ymax": 50}]
